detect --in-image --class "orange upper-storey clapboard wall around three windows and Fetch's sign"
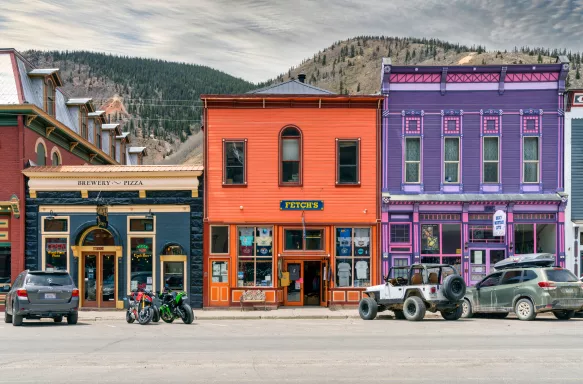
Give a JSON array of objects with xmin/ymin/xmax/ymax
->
[{"xmin": 205, "ymin": 108, "xmax": 379, "ymax": 225}]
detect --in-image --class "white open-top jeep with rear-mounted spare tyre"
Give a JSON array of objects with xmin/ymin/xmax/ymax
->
[{"xmin": 358, "ymin": 264, "xmax": 466, "ymax": 321}]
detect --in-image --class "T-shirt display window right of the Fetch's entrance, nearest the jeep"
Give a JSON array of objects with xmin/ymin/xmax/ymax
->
[{"xmin": 336, "ymin": 228, "xmax": 371, "ymax": 288}]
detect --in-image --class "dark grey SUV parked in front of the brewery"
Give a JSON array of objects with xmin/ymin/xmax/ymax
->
[{"xmin": 4, "ymin": 270, "xmax": 79, "ymax": 326}]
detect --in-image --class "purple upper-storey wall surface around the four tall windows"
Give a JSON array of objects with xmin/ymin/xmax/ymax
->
[{"xmin": 383, "ymin": 89, "xmax": 562, "ymax": 193}]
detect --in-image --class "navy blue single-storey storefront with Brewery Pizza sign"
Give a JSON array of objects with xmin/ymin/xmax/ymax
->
[{"xmin": 24, "ymin": 166, "xmax": 203, "ymax": 308}]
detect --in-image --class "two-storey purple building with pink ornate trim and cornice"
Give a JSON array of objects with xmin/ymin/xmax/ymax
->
[{"xmin": 381, "ymin": 58, "xmax": 569, "ymax": 285}]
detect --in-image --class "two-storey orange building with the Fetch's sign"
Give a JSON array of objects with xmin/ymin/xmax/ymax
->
[{"xmin": 202, "ymin": 77, "xmax": 382, "ymax": 307}]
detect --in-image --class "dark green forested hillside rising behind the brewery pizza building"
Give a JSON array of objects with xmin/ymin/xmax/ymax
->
[{"xmin": 24, "ymin": 51, "xmax": 257, "ymax": 164}]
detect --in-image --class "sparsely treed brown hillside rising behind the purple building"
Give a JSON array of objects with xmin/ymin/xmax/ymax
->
[{"xmin": 270, "ymin": 36, "xmax": 583, "ymax": 94}]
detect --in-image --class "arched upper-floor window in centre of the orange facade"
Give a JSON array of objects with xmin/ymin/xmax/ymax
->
[{"xmin": 279, "ymin": 127, "xmax": 302, "ymax": 185}]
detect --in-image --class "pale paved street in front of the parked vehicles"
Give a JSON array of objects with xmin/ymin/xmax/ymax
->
[{"xmin": 0, "ymin": 318, "xmax": 583, "ymax": 383}]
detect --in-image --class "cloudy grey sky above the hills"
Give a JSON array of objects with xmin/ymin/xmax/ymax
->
[{"xmin": 0, "ymin": 0, "xmax": 583, "ymax": 82}]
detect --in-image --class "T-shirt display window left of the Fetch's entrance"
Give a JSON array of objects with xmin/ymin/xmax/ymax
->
[{"xmin": 237, "ymin": 227, "xmax": 273, "ymax": 287}]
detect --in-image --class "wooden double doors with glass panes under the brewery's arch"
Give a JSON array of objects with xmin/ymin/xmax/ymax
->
[{"xmin": 81, "ymin": 252, "xmax": 117, "ymax": 308}]
